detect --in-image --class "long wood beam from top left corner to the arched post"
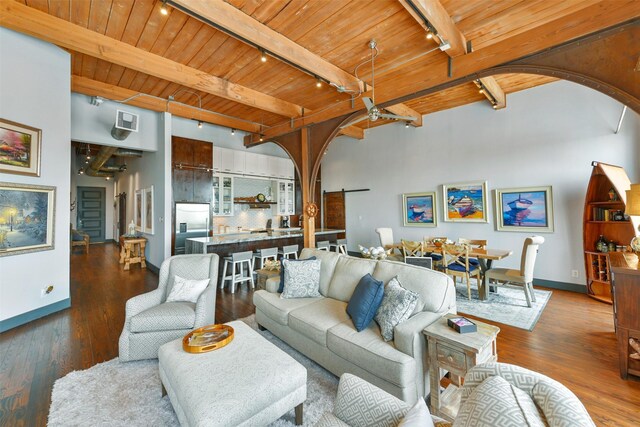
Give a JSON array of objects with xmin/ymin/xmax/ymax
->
[{"xmin": 0, "ymin": 1, "xmax": 302, "ymax": 117}]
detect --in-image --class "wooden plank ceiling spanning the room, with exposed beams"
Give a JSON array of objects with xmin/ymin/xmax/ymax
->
[{"xmin": 6, "ymin": 0, "xmax": 640, "ymax": 135}]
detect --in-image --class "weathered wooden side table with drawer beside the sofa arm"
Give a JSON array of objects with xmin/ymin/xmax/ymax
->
[{"xmin": 422, "ymin": 314, "xmax": 500, "ymax": 421}]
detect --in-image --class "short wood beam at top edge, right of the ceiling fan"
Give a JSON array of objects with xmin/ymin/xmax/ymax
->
[{"xmin": 399, "ymin": 0, "xmax": 467, "ymax": 57}]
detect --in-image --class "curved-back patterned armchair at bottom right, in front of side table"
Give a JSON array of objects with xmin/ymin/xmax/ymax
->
[{"xmin": 453, "ymin": 363, "xmax": 595, "ymax": 427}]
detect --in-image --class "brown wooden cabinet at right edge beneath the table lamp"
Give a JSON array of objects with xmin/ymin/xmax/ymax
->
[{"xmin": 609, "ymin": 252, "xmax": 640, "ymax": 380}]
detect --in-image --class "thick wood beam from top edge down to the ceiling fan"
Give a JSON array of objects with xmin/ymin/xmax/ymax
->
[{"xmin": 168, "ymin": 0, "xmax": 364, "ymax": 91}]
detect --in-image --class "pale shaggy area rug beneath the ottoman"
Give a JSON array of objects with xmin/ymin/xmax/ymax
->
[{"xmin": 48, "ymin": 316, "xmax": 338, "ymax": 427}]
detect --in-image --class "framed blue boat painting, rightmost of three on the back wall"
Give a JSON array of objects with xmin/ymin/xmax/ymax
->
[{"xmin": 496, "ymin": 186, "xmax": 553, "ymax": 233}]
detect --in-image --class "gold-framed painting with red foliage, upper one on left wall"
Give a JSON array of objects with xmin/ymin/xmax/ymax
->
[{"xmin": 0, "ymin": 119, "xmax": 42, "ymax": 176}]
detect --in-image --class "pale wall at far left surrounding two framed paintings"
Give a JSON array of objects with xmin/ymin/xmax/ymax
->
[{"xmin": 0, "ymin": 28, "xmax": 71, "ymax": 321}]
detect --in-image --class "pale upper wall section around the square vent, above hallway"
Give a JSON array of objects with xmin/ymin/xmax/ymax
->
[{"xmin": 71, "ymin": 93, "xmax": 160, "ymax": 151}]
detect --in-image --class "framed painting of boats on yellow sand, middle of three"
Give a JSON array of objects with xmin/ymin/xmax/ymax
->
[{"xmin": 442, "ymin": 181, "xmax": 489, "ymax": 222}]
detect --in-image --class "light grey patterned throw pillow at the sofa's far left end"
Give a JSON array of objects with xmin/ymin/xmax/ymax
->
[{"xmin": 280, "ymin": 259, "xmax": 322, "ymax": 298}]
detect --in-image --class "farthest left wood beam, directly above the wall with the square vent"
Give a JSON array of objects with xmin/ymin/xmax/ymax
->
[{"xmin": 71, "ymin": 76, "xmax": 260, "ymax": 132}]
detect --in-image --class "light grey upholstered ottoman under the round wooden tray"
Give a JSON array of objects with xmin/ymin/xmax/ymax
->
[{"xmin": 158, "ymin": 321, "xmax": 307, "ymax": 426}]
